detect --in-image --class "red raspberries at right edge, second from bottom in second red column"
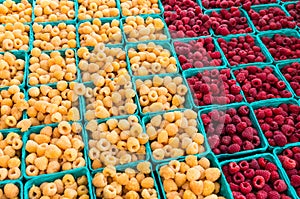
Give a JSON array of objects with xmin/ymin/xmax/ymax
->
[{"xmin": 254, "ymin": 104, "xmax": 300, "ymax": 147}]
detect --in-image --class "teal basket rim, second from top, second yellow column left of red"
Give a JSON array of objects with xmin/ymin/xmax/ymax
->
[{"xmin": 76, "ymin": 18, "xmax": 124, "ymax": 48}]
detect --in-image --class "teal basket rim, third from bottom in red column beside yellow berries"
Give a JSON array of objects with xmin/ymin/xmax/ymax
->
[{"xmin": 183, "ymin": 67, "xmax": 246, "ymax": 110}]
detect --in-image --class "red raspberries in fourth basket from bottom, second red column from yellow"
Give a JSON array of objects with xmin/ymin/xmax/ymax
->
[{"xmin": 218, "ymin": 35, "xmax": 266, "ymax": 66}]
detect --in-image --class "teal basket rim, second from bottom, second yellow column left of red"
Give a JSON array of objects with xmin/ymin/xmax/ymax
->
[{"xmin": 84, "ymin": 114, "xmax": 150, "ymax": 173}]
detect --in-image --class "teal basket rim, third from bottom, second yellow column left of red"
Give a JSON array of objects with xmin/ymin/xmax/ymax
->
[{"xmin": 79, "ymin": 79, "xmax": 139, "ymax": 123}]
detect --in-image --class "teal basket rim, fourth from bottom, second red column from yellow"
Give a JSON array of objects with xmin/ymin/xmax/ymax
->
[{"xmin": 217, "ymin": 34, "xmax": 273, "ymax": 68}]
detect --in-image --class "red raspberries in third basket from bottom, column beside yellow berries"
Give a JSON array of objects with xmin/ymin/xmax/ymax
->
[{"xmin": 187, "ymin": 69, "xmax": 243, "ymax": 106}]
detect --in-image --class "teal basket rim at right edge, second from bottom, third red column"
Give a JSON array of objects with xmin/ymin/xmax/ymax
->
[{"xmin": 258, "ymin": 29, "xmax": 300, "ymax": 64}]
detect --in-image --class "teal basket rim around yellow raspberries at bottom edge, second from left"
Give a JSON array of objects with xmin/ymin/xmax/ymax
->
[{"xmin": 24, "ymin": 168, "xmax": 93, "ymax": 199}]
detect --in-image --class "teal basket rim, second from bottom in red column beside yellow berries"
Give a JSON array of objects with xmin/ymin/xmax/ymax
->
[{"xmin": 198, "ymin": 103, "xmax": 268, "ymax": 160}]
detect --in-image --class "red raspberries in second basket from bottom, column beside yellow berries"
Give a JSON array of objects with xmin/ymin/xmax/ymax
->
[{"xmin": 201, "ymin": 105, "xmax": 261, "ymax": 155}]
